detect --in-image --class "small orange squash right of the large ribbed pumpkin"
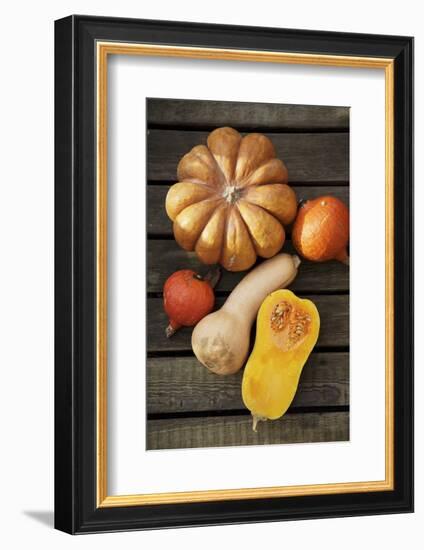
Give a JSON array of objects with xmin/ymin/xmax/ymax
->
[{"xmin": 292, "ymin": 197, "xmax": 349, "ymax": 264}]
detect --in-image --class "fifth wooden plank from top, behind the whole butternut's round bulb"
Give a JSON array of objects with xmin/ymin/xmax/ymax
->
[{"xmin": 147, "ymin": 295, "xmax": 349, "ymax": 355}]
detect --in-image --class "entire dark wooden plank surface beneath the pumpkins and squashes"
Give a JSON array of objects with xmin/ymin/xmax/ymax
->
[{"xmin": 146, "ymin": 99, "xmax": 349, "ymax": 449}]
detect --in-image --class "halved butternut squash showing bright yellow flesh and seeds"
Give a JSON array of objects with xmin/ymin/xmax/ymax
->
[{"xmin": 242, "ymin": 289, "xmax": 320, "ymax": 431}]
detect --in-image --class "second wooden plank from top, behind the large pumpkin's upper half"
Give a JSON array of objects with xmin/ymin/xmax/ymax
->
[{"xmin": 147, "ymin": 130, "xmax": 349, "ymax": 184}]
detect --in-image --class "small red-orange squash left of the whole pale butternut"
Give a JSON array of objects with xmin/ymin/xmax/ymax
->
[{"xmin": 163, "ymin": 269, "xmax": 215, "ymax": 338}]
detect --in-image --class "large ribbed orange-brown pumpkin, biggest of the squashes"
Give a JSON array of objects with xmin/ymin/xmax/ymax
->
[{"xmin": 166, "ymin": 128, "xmax": 297, "ymax": 271}]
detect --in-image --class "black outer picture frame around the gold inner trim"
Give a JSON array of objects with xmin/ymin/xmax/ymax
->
[{"xmin": 55, "ymin": 15, "xmax": 413, "ymax": 534}]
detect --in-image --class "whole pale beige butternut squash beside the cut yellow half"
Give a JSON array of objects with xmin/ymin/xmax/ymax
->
[{"xmin": 191, "ymin": 254, "xmax": 300, "ymax": 374}]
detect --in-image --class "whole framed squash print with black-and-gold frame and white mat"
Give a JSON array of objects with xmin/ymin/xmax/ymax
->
[{"xmin": 55, "ymin": 16, "xmax": 413, "ymax": 534}]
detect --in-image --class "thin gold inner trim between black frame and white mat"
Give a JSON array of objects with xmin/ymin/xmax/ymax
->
[{"xmin": 96, "ymin": 41, "xmax": 394, "ymax": 508}]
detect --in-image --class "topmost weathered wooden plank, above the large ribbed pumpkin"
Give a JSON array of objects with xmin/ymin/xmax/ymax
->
[{"xmin": 147, "ymin": 98, "xmax": 349, "ymax": 130}]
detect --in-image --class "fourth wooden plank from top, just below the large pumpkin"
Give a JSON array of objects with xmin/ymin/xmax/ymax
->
[{"xmin": 147, "ymin": 240, "xmax": 349, "ymax": 293}]
